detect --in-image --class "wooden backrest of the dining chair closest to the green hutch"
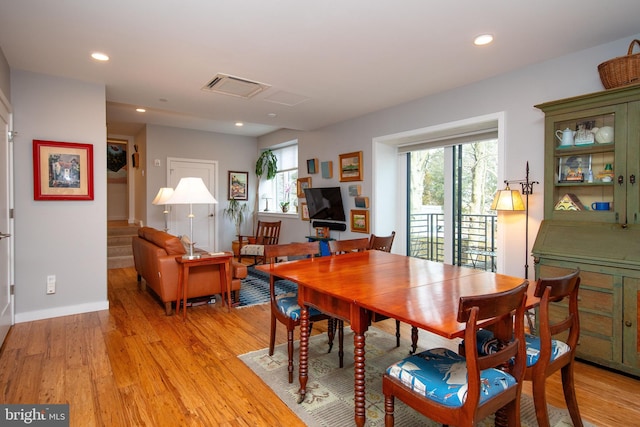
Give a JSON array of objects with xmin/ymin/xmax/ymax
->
[{"xmin": 534, "ymin": 269, "xmax": 580, "ymax": 352}]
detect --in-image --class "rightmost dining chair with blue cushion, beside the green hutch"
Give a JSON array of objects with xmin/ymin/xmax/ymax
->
[{"xmin": 468, "ymin": 270, "xmax": 582, "ymax": 427}]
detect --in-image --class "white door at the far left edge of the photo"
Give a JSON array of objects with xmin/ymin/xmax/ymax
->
[{"xmin": 0, "ymin": 93, "xmax": 13, "ymax": 345}]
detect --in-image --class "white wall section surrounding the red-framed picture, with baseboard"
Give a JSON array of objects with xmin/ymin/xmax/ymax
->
[{"xmin": 11, "ymin": 69, "xmax": 109, "ymax": 323}]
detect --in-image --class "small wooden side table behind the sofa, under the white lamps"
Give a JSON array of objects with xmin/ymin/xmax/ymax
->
[{"xmin": 176, "ymin": 252, "xmax": 233, "ymax": 319}]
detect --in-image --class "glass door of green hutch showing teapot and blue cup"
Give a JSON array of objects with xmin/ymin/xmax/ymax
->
[{"xmin": 545, "ymin": 105, "xmax": 626, "ymax": 222}]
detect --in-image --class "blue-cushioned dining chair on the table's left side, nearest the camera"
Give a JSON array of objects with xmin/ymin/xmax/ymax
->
[{"xmin": 264, "ymin": 241, "xmax": 344, "ymax": 383}]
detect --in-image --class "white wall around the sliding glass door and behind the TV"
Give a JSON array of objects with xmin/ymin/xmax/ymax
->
[{"xmin": 258, "ymin": 36, "xmax": 638, "ymax": 277}]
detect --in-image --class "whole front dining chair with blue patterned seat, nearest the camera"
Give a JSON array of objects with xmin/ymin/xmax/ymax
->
[{"xmin": 382, "ymin": 281, "xmax": 528, "ymax": 427}]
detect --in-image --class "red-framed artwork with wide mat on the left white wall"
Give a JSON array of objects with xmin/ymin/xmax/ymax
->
[{"xmin": 33, "ymin": 139, "xmax": 93, "ymax": 200}]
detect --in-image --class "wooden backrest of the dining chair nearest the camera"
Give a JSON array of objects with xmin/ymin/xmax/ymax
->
[{"xmin": 458, "ymin": 281, "xmax": 529, "ymax": 408}]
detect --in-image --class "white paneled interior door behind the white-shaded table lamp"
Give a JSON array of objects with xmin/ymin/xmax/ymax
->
[{"xmin": 167, "ymin": 158, "xmax": 220, "ymax": 252}]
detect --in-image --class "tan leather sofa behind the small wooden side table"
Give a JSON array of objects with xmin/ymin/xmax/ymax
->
[{"xmin": 131, "ymin": 227, "xmax": 247, "ymax": 316}]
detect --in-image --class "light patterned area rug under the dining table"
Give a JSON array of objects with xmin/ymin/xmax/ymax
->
[{"xmin": 239, "ymin": 328, "xmax": 594, "ymax": 427}]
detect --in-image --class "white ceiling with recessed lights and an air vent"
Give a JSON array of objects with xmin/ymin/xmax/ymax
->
[{"xmin": 0, "ymin": 0, "xmax": 640, "ymax": 136}]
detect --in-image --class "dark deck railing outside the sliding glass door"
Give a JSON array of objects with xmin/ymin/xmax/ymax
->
[{"xmin": 408, "ymin": 213, "xmax": 498, "ymax": 271}]
